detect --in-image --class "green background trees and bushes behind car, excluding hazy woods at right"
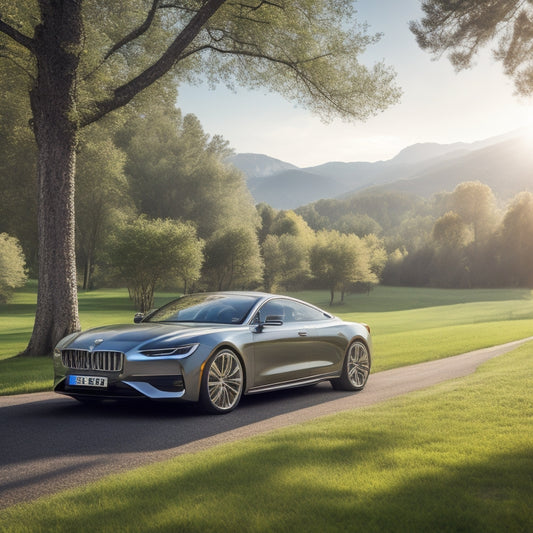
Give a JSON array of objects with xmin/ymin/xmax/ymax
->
[{"xmin": 0, "ymin": 82, "xmax": 385, "ymax": 311}]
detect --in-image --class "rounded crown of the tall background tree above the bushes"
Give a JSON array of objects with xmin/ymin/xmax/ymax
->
[{"xmin": 116, "ymin": 104, "xmax": 257, "ymax": 239}]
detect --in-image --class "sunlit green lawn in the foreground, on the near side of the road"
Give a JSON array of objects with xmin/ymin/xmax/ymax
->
[{"xmin": 0, "ymin": 343, "xmax": 533, "ymax": 533}]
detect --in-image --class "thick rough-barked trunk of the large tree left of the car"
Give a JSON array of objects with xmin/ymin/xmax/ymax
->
[{"xmin": 22, "ymin": 0, "xmax": 82, "ymax": 356}]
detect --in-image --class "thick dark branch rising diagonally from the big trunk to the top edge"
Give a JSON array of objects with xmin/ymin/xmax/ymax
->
[{"xmin": 80, "ymin": 0, "xmax": 226, "ymax": 127}]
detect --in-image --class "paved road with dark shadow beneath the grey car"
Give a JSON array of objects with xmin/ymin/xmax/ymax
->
[{"xmin": 0, "ymin": 337, "xmax": 533, "ymax": 508}]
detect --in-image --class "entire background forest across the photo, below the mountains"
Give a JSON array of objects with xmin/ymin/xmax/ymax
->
[{"xmin": 0, "ymin": 64, "xmax": 533, "ymax": 311}]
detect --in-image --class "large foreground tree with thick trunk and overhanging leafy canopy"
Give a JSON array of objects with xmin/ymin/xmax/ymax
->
[{"xmin": 0, "ymin": 0, "xmax": 398, "ymax": 355}]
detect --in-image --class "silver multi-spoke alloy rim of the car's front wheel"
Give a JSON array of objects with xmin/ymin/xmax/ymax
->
[{"xmin": 207, "ymin": 351, "xmax": 243, "ymax": 410}]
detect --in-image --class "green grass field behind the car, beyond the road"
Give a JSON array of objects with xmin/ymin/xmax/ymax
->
[{"xmin": 0, "ymin": 283, "xmax": 533, "ymax": 394}]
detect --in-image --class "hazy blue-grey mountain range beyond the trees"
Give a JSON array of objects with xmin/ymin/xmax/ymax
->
[{"xmin": 230, "ymin": 131, "xmax": 533, "ymax": 209}]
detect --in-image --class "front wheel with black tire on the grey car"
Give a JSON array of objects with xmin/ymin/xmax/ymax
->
[{"xmin": 200, "ymin": 348, "xmax": 244, "ymax": 415}]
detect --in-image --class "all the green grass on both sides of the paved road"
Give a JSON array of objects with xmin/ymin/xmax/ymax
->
[{"xmin": 0, "ymin": 286, "xmax": 533, "ymax": 533}]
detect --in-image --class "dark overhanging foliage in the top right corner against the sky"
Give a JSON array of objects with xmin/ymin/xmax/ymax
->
[{"xmin": 410, "ymin": 0, "xmax": 533, "ymax": 95}]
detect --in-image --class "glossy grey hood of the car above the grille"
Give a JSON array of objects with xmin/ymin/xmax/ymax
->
[{"xmin": 57, "ymin": 323, "xmax": 235, "ymax": 352}]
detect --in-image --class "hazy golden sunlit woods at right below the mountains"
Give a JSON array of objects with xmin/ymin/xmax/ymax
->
[{"xmin": 296, "ymin": 181, "xmax": 533, "ymax": 288}]
